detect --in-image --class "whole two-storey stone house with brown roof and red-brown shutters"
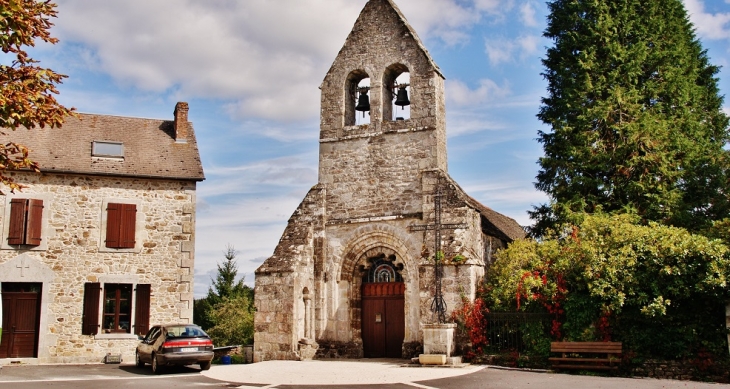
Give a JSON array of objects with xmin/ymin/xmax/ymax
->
[{"xmin": 0, "ymin": 103, "xmax": 204, "ymax": 364}]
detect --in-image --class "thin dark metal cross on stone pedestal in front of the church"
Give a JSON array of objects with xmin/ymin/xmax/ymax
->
[{"xmin": 410, "ymin": 177, "xmax": 467, "ymax": 324}]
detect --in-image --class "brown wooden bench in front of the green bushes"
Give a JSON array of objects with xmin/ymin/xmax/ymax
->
[{"xmin": 549, "ymin": 342, "xmax": 622, "ymax": 370}]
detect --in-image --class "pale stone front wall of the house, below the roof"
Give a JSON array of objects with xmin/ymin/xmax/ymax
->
[{"xmin": 0, "ymin": 173, "xmax": 196, "ymax": 363}]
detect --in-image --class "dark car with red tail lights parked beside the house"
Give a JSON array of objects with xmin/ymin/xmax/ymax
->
[{"xmin": 135, "ymin": 324, "xmax": 213, "ymax": 374}]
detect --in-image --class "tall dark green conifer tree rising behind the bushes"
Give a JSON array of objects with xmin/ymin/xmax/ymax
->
[{"xmin": 531, "ymin": 0, "xmax": 730, "ymax": 235}]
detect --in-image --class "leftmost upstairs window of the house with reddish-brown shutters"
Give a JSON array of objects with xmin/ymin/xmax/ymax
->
[{"xmin": 8, "ymin": 199, "xmax": 43, "ymax": 246}]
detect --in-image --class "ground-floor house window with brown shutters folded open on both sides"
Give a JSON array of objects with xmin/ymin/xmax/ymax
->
[{"xmin": 81, "ymin": 282, "xmax": 151, "ymax": 335}]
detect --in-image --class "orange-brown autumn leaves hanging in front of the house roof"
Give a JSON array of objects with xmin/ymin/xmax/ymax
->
[{"xmin": 0, "ymin": 0, "xmax": 74, "ymax": 191}]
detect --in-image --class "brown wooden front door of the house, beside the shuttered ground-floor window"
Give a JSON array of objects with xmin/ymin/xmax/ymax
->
[{"xmin": 0, "ymin": 282, "xmax": 41, "ymax": 358}]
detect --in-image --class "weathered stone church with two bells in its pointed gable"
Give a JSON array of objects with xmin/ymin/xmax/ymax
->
[{"xmin": 254, "ymin": 0, "xmax": 525, "ymax": 362}]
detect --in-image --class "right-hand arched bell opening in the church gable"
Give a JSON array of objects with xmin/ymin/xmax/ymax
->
[{"xmin": 383, "ymin": 63, "xmax": 412, "ymax": 121}]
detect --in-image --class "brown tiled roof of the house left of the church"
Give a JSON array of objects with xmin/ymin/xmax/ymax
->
[{"xmin": 5, "ymin": 103, "xmax": 205, "ymax": 181}]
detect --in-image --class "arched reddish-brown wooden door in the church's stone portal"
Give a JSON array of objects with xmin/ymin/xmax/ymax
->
[{"xmin": 361, "ymin": 258, "xmax": 405, "ymax": 358}]
